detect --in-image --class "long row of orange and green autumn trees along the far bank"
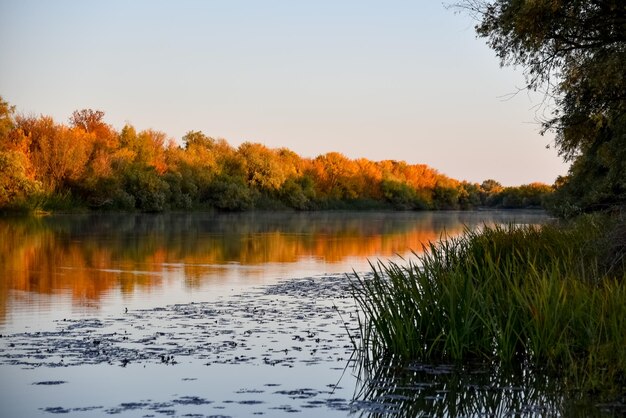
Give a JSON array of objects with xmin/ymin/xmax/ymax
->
[{"xmin": 0, "ymin": 98, "xmax": 552, "ymax": 212}]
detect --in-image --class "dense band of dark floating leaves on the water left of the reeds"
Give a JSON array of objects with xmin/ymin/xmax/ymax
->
[{"xmin": 0, "ymin": 275, "xmax": 356, "ymax": 370}]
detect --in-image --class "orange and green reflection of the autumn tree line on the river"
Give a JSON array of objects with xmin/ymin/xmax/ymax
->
[{"xmin": 0, "ymin": 212, "xmax": 545, "ymax": 323}]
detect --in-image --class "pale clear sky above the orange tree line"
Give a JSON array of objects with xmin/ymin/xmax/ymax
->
[{"xmin": 0, "ymin": 0, "xmax": 568, "ymax": 186}]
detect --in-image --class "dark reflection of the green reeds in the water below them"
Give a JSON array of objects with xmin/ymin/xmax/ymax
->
[{"xmin": 354, "ymin": 361, "xmax": 603, "ymax": 418}]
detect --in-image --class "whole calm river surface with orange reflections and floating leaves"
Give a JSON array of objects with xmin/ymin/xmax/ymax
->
[{"xmin": 0, "ymin": 212, "xmax": 613, "ymax": 417}]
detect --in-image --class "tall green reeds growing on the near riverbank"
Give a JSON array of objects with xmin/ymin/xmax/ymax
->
[{"xmin": 351, "ymin": 215, "xmax": 626, "ymax": 402}]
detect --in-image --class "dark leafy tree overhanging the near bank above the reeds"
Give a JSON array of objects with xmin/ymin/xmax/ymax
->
[{"xmin": 456, "ymin": 0, "xmax": 626, "ymax": 215}]
